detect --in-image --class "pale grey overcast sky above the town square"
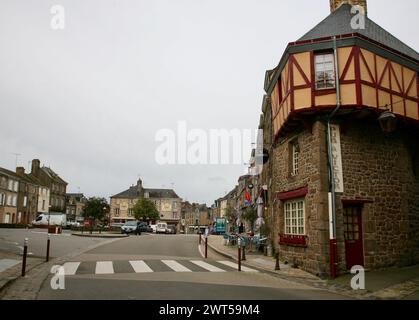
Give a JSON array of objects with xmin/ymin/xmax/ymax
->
[{"xmin": 0, "ymin": 0, "xmax": 419, "ymax": 204}]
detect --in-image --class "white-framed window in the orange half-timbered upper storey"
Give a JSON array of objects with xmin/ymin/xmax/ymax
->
[{"xmin": 314, "ymin": 53, "xmax": 335, "ymax": 89}]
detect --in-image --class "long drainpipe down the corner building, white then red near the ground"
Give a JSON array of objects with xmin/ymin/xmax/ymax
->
[{"xmin": 327, "ymin": 36, "xmax": 341, "ymax": 278}]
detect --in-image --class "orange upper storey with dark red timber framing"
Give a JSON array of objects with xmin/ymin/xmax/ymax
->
[{"xmin": 272, "ymin": 46, "xmax": 419, "ymax": 138}]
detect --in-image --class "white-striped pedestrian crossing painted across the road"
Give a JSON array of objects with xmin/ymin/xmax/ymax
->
[{"xmin": 63, "ymin": 260, "xmax": 258, "ymax": 276}]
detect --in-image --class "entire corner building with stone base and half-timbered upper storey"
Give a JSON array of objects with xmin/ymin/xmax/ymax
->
[{"xmin": 261, "ymin": 1, "xmax": 419, "ymax": 276}]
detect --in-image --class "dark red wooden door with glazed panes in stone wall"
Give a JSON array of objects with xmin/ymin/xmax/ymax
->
[{"xmin": 343, "ymin": 206, "xmax": 364, "ymax": 270}]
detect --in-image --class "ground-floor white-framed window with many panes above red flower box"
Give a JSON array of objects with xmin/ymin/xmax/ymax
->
[{"xmin": 284, "ymin": 199, "xmax": 305, "ymax": 235}]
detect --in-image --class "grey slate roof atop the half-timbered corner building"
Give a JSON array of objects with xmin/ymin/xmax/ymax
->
[{"xmin": 298, "ymin": 4, "xmax": 419, "ymax": 60}]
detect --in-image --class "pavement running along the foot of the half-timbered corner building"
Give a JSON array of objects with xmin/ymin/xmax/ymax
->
[{"xmin": 208, "ymin": 235, "xmax": 419, "ymax": 300}]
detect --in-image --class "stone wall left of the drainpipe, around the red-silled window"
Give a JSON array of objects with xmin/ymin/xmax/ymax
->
[{"xmin": 272, "ymin": 121, "xmax": 329, "ymax": 276}]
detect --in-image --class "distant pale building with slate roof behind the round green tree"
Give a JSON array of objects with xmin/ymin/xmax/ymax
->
[{"xmin": 110, "ymin": 179, "xmax": 182, "ymax": 232}]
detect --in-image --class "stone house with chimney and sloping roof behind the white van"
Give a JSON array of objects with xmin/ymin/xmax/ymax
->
[{"xmin": 30, "ymin": 159, "xmax": 68, "ymax": 213}]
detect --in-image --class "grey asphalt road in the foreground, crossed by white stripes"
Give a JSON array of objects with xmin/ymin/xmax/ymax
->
[{"xmin": 38, "ymin": 234, "xmax": 343, "ymax": 300}]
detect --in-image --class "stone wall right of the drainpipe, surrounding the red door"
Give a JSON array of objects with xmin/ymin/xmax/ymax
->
[{"xmin": 337, "ymin": 122, "xmax": 419, "ymax": 268}]
